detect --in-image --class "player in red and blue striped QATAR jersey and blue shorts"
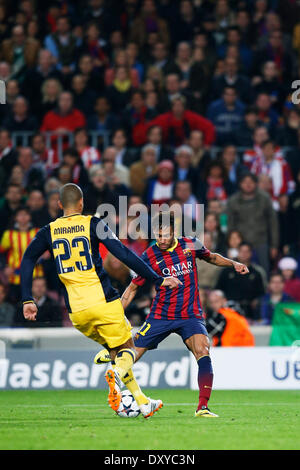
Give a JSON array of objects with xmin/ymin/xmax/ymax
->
[{"xmin": 98, "ymin": 212, "xmax": 248, "ymax": 417}]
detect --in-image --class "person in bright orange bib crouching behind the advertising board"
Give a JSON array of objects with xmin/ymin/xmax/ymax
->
[{"xmin": 206, "ymin": 290, "xmax": 255, "ymax": 347}]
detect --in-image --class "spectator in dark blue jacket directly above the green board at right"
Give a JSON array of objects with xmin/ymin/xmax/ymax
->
[{"xmin": 260, "ymin": 273, "xmax": 294, "ymax": 325}]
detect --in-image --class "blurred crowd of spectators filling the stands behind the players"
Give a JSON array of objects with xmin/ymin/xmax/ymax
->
[{"xmin": 0, "ymin": 0, "xmax": 300, "ymax": 336}]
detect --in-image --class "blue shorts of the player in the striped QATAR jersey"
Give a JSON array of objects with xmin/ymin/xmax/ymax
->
[{"xmin": 134, "ymin": 317, "xmax": 208, "ymax": 349}]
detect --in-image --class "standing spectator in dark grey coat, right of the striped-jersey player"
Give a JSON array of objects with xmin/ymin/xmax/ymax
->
[{"xmin": 227, "ymin": 174, "xmax": 279, "ymax": 273}]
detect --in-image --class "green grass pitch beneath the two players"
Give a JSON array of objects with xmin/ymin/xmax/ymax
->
[{"xmin": 0, "ymin": 389, "xmax": 300, "ymax": 450}]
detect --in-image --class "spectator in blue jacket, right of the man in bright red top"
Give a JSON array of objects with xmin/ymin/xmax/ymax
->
[{"xmin": 207, "ymin": 85, "xmax": 245, "ymax": 145}]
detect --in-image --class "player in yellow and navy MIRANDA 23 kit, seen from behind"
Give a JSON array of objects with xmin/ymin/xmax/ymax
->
[{"xmin": 21, "ymin": 183, "xmax": 180, "ymax": 418}]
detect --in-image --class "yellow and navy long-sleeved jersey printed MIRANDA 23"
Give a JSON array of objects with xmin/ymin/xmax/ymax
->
[{"xmin": 21, "ymin": 214, "xmax": 163, "ymax": 313}]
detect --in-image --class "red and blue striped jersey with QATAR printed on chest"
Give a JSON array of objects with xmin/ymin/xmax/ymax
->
[{"xmin": 132, "ymin": 237, "xmax": 210, "ymax": 320}]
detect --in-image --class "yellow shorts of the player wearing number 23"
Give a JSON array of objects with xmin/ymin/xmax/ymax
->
[{"xmin": 69, "ymin": 299, "xmax": 132, "ymax": 349}]
